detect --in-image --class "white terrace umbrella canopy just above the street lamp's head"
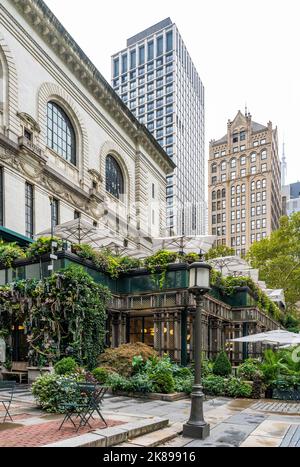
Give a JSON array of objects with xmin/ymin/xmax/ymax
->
[{"xmin": 152, "ymin": 235, "xmax": 216, "ymax": 253}]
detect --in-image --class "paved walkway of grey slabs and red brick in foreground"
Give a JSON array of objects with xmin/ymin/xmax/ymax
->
[{"xmin": 0, "ymin": 389, "xmax": 300, "ymax": 448}]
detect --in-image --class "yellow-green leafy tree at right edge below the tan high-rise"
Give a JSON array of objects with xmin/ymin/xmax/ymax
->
[{"xmin": 247, "ymin": 212, "xmax": 300, "ymax": 311}]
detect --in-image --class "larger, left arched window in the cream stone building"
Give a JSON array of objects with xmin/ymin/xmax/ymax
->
[{"xmin": 47, "ymin": 102, "xmax": 76, "ymax": 165}]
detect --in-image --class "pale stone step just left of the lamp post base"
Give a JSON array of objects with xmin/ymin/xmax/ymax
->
[{"xmin": 116, "ymin": 423, "xmax": 182, "ymax": 448}]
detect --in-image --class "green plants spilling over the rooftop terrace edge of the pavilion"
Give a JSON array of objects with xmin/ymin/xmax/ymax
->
[{"xmin": 0, "ymin": 237, "xmax": 284, "ymax": 321}]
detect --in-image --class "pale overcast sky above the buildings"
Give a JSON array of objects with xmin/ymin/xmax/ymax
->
[{"xmin": 46, "ymin": 0, "xmax": 300, "ymax": 183}]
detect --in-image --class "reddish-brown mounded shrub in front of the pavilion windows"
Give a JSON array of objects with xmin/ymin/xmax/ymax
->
[{"xmin": 99, "ymin": 342, "xmax": 157, "ymax": 377}]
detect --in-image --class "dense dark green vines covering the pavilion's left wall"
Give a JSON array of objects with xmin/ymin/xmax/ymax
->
[{"xmin": 0, "ymin": 266, "xmax": 110, "ymax": 368}]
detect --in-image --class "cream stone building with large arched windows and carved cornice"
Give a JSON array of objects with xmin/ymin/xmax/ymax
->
[{"xmin": 0, "ymin": 0, "xmax": 175, "ymax": 250}]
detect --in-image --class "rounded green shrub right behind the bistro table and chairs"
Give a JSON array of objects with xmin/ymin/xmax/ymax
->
[{"xmin": 32, "ymin": 374, "xmax": 83, "ymax": 413}]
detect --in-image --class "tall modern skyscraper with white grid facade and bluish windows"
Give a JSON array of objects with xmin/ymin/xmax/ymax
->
[{"xmin": 112, "ymin": 18, "xmax": 206, "ymax": 235}]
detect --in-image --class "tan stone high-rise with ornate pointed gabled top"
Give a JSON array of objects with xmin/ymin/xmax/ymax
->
[{"xmin": 208, "ymin": 111, "xmax": 281, "ymax": 256}]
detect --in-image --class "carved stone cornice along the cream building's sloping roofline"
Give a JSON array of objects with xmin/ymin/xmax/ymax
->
[{"xmin": 10, "ymin": 0, "xmax": 175, "ymax": 173}]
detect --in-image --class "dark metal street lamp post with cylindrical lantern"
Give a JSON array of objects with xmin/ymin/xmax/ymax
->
[{"xmin": 183, "ymin": 262, "xmax": 211, "ymax": 439}]
